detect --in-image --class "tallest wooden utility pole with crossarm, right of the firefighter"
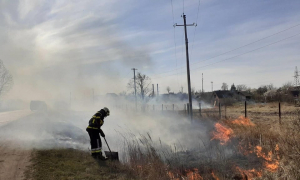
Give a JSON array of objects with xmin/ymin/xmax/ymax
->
[{"xmin": 174, "ymin": 14, "xmax": 197, "ymax": 121}]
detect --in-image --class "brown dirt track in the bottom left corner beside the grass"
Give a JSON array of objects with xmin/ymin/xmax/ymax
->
[{"xmin": 0, "ymin": 141, "xmax": 31, "ymax": 180}]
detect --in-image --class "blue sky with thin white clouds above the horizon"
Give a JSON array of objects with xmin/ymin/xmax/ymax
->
[{"xmin": 0, "ymin": 0, "xmax": 300, "ymax": 100}]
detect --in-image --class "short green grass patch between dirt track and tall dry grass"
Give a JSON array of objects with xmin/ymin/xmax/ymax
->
[{"xmin": 25, "ymin": 149, "xmax": 137, "ymax": 180}]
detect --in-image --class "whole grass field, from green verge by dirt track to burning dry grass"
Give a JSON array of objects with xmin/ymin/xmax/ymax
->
[{"xmin": 26, "ymin": 103, "xmax": 300, "ymax": 180}]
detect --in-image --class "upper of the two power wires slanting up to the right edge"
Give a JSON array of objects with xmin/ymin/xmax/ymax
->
[{"xmin": 154, "ymin": 24, "xmax": 300, "ymax": 75}]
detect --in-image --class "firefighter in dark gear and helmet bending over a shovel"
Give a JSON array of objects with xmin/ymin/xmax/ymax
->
[{"xmin": 86, "ymin": 107, "xmax": 110, "ymax": 160}]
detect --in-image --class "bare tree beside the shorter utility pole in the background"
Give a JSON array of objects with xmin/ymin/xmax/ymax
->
[{"xmin": 127, "ymin": 73, "xmax": 152, "ymax": 100}]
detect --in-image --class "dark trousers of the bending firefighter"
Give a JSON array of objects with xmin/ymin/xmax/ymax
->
[{"xmin": 87, "ymin": 128, "xmax": 102, "ymax": 156}]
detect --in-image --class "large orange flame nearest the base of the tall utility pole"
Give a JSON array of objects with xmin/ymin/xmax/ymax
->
[{"xmin": 211, "ymin": 123, "xmax": 233, "ymax": 145}]
